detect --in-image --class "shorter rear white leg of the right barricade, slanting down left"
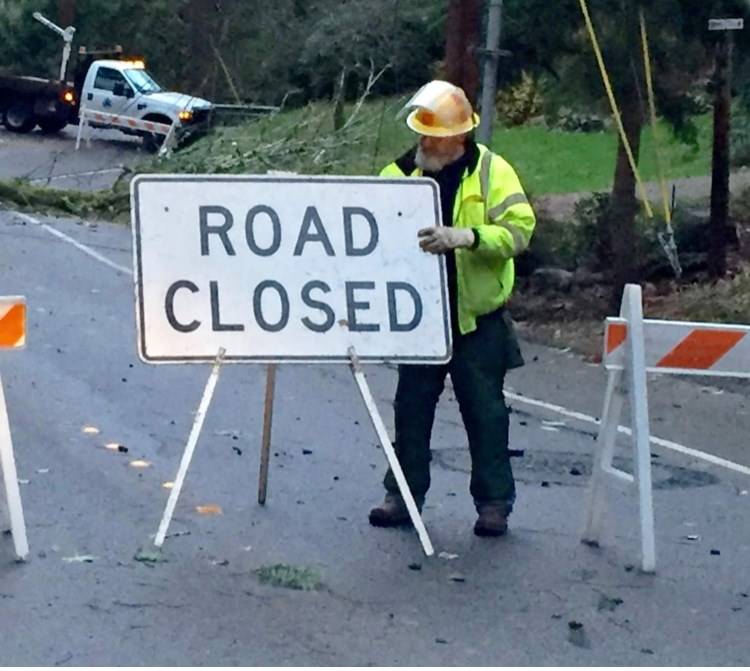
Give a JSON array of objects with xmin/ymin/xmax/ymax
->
[{"xmin": 582, "ymin": 371, "xmax": 625, "ymax": 545}]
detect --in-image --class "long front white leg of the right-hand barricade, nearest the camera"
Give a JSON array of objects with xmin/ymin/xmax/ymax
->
[{"xmin": 623, "ymin": 284, "xmax": 656, "ymax": 573}]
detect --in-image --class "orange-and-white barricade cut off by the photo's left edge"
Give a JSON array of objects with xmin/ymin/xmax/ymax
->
[{"xmin": 0, "ymin": 296, "xmax": 29, "ymax": 559}]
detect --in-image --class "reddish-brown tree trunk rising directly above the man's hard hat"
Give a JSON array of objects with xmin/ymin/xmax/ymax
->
[{"xmin": 445, "ymin": 0, "xmax": 482, "ymax": 106}]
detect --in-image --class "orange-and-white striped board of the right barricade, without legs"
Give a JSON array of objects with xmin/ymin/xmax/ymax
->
[{"xmin": 603, "ymin": 317, "xmax": 750, "ymax": 377}]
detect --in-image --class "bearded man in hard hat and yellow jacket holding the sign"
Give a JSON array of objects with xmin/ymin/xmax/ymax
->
[{"xmin": 370, "ymin": 81, "xmax": 535, "ymax": 536}]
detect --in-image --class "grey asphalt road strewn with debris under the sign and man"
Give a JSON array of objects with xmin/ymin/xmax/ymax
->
[{"xmin": 0, "ymin": 126, "xmax": 750, "ymax": 666}]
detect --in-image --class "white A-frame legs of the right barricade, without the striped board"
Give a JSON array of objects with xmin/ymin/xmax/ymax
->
[{"xmin": 582, "ymin": 284, "xmax": 656, "ymax": 573}]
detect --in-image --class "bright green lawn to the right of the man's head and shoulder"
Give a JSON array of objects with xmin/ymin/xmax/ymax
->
[{"xmin": 492, "ymin": 116, "xmax": 711, "ymax": 195}]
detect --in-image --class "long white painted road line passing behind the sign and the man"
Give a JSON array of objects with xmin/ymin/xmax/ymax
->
[{"xmin": 5, "ymin": 207, "xmax": 750, "ymax": 475}]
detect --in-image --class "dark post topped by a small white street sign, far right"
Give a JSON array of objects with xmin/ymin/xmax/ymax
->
[{"xmin": 708, "ymin": 19, "xmax": 744, "ymax": 278}]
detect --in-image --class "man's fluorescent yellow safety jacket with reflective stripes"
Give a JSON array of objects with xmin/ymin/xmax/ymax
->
[{"xmin": 380, "ymin": 144, "xmax": 536, "ymax": 335}]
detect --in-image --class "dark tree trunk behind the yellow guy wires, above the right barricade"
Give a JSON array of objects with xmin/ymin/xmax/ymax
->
[{"xmin": 602, "ymin": 91, "xmax": 643, "ymax": 308}]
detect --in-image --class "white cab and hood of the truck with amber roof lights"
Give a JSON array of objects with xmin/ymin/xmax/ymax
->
[{"xmin": 79, "ymin": 59, "xmax": 212, "ymax": 138}]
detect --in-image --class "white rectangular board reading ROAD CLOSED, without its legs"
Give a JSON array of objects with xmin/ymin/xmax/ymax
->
[{"xmin": 131, "ymin": 175, "xmax": 451, "ymax": 363}]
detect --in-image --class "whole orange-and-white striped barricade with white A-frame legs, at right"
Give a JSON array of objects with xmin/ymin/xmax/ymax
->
[{"xmin": 583, "ymin": 284, "xmax": 750, "ymax": 572}]
